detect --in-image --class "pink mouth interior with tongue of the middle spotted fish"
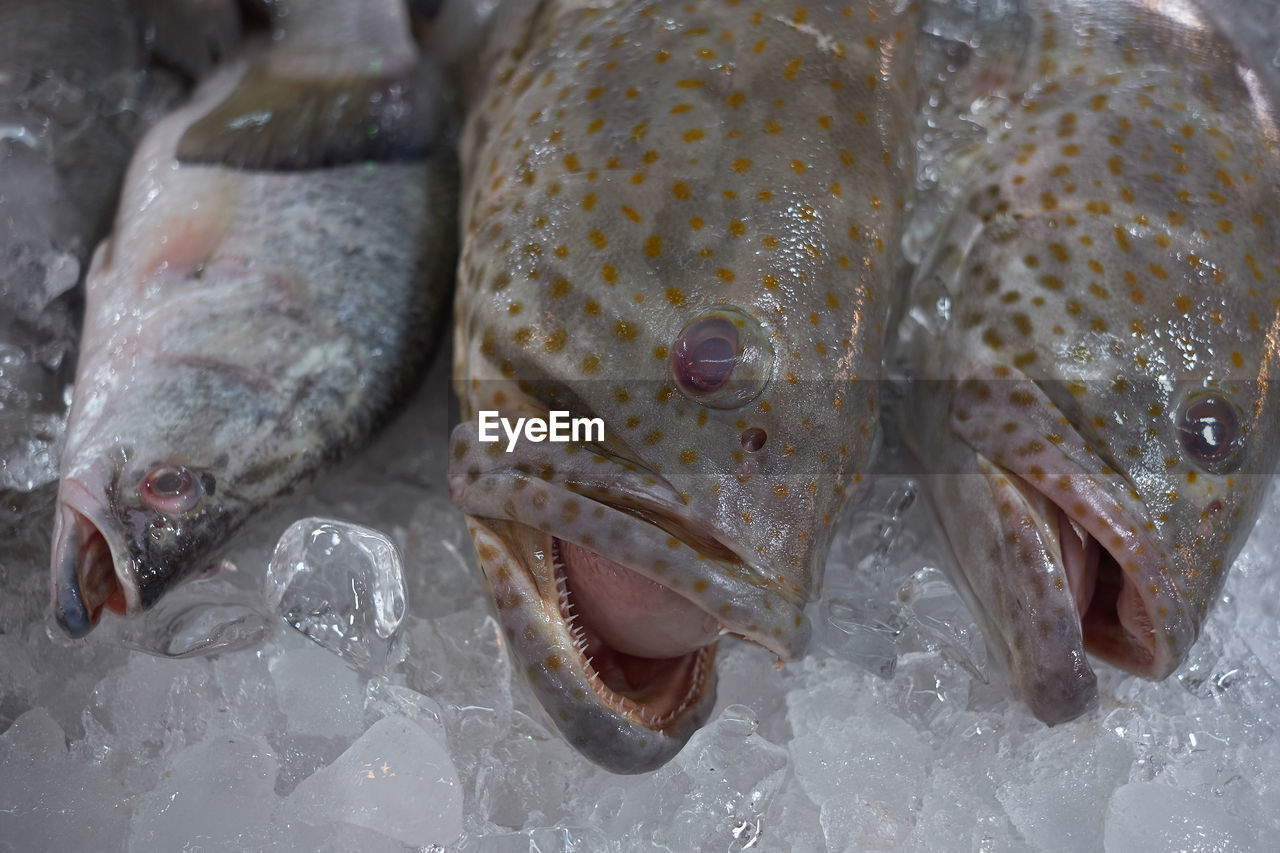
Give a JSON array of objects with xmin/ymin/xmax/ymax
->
[{"xmin": 550, "ymin": 537, "xmax": 718, "ymax": 730}]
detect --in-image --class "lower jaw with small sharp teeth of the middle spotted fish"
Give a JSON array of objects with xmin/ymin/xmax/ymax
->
[{"xmin": 467, "ymin": 516, "xmax": 716, "ymax": 774}]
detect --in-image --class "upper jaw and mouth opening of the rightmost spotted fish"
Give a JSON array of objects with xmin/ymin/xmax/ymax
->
[{"xmin": 951, "ymin": 378, "xmax": 1196, "ymax": 680}]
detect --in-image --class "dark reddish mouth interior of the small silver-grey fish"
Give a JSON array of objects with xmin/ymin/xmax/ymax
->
[{"xmin": 56, "ymin": 507, "xmax": 128, "ymax": 637}]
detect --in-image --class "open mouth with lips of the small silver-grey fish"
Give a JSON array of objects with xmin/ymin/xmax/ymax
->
[{"xmin": 52, "ymin": 478, "xmax": 140, "ymax": 638}]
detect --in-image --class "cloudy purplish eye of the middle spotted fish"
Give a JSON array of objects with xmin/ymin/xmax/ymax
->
[{"xmin": 671, "ymin": 307, "xmax": 773, "ymax": 409}]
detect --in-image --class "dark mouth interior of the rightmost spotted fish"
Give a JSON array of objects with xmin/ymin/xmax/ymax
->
[{"xmin": 1001, "ymin": 469, "xmax": 1164, "ymax": 678}]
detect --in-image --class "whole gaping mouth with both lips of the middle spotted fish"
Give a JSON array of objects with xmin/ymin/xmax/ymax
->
[{"xmin": 449, "ymin": 424, "xmax": 808, "ymax": 772}]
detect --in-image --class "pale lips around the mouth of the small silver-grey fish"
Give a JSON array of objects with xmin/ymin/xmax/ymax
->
[{"xmin": 50, "ymin": 476, "xmax": 141, "ymax": 638}]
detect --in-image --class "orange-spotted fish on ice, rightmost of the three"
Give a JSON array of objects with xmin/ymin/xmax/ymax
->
[{"xmin": 900, "ymin": 0, "xmax": 1280, "ymax": 724}]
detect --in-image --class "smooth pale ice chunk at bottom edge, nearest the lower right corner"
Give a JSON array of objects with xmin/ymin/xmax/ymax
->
[{"xmin": 1103, "ymin": 783, "xmax": 1263, "ymax": 853}]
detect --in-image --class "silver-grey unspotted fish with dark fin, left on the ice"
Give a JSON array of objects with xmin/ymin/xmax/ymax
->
[{"xmin": 51, "ymin": 0, "xmax": 457, "ymax": 637}]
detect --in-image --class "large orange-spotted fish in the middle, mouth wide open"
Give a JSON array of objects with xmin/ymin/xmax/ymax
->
[{"xmin": 449, "ymin": 0, "xmax": 918, "ymax": 772}]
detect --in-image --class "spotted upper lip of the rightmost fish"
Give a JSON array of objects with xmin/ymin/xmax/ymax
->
[{"xmin": 951, "ymin": 378, "xmax": 1194, "ymax": 680}]
